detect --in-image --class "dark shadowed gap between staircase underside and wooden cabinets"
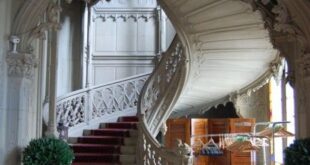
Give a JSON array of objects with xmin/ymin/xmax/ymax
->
[{"xmin": 203, "ymin": 102, "xmax": 239, "ymax": 119}]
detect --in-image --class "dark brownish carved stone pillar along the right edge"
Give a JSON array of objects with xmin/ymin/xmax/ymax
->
[{"xmin": 275, "ymin": 0, "xmax": 310, "ymax": 138}]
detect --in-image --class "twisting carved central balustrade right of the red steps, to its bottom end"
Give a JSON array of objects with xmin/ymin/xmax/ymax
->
[{"xmin": 137, "ymin": 37, "xmax": 192, "ymax": 165}]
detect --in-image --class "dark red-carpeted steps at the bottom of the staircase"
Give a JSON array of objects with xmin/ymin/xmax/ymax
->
[{"xmin": 69, "ymin": 116, "xmax": 138, "ymax": 165}]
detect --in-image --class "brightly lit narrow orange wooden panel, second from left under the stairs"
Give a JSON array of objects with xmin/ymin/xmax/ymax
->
[{"xmin": 191, "ymin": 119, "xmax": 208, "ymax": 165}]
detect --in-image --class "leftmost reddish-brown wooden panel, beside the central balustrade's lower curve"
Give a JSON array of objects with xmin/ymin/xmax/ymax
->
[{"xmin": 165, "ymin": 119, "xmax": 191, "ymax": 149}]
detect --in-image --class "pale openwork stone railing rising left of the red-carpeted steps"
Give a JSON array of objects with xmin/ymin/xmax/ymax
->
[{"xmin": 56, "ymin": 74, "xmax": 149, "ymax": 134}]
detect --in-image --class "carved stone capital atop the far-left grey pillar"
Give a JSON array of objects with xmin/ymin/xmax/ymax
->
[{"xmin": 6, "ymin": 52, "xmax": 38, "ymax": 79}]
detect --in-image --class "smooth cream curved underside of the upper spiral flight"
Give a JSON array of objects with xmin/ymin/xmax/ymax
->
[{"xmin": 160, "ymin": 0, "xmax": 278, "ymax": 116}]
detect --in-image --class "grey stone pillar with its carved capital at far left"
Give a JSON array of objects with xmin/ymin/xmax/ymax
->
[{"xmin": 4, "ymin": 49, "xmax": 37, "ymax": 165}]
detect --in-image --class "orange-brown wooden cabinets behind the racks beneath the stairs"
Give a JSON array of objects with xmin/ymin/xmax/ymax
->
[{"xmin": 165, "ymin": 118, "xmax": 255, "ymax": 165}]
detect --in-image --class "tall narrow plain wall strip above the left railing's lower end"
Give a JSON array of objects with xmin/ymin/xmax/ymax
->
[{"xmin": 57, "ymin": 1, "xmax": 84, "ymax": 96}]
